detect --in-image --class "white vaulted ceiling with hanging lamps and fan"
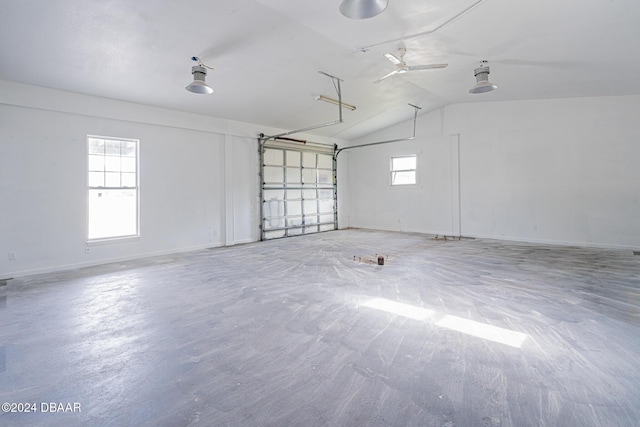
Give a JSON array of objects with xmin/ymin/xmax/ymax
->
[{"xmin": 0, "ymin": 0, "xmax": 640, "ymax": 139}]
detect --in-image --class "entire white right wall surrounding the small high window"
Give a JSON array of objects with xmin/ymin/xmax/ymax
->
[{"xmin": 349, "ymin": 96, "xmax": 640, "ymax": 248}]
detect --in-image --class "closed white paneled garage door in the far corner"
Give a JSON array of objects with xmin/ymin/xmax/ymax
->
[{"xmin": 260, "ymin": 141, "xmax": 337, "ymax": 240}]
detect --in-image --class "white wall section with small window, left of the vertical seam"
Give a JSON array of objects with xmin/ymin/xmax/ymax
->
[{"xmin": 341, "ymin": 113, "xmax": 457, "ymax": 234}]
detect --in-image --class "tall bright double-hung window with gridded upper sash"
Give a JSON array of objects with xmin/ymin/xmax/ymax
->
[{"xmin": 87, "ymin": 136, "xmax": 139, "ymax": 241}]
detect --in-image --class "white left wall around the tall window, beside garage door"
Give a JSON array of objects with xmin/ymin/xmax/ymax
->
[{"xmin": 0, "ymin": 82, "xmax": 279, "ymax": 279}]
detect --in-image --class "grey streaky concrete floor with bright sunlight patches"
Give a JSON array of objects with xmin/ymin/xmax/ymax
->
[{"xmin": 0, "ymin": 230, "xmax": 640, "ymax": 427}]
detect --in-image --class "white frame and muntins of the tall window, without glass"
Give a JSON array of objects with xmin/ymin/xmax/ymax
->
[{"xmin": 85, "ymin": 135, "xmax": 140, "ymax": 242}]
